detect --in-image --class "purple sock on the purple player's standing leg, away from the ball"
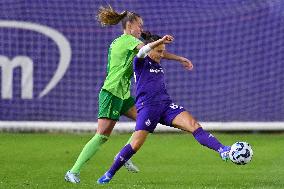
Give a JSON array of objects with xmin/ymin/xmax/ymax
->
[{"xmin": 108, "ymin": 144, "xmax": 136, "ymax": 176}]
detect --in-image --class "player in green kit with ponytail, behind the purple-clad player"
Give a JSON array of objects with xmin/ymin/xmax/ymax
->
[{"xmin": 65, "ymin": 6, "xmax": 191, "ymax": 183}]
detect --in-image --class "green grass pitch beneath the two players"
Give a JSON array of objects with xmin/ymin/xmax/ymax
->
[{"xmin": 0, "ymin": 133, "xmax": 284, "ymax": 189}]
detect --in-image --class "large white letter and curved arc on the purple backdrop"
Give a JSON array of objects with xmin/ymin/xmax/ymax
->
[{"xmin": 0, "ymin": 20, "xmax": 72, "ymax": 99}]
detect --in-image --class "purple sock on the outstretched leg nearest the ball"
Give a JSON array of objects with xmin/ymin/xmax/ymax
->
[{"xmin": 192, "ymin": 127, "xmax": 224, "ymax": 152}]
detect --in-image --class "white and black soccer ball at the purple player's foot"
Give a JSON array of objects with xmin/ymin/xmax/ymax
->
[{"xmin": 229, "ymin": 142, "xmax": 253, "ymax": 165}]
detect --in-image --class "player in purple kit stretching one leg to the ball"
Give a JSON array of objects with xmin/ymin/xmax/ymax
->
[{"xmin": 97, "ymin": 35, "xmax": 230, "ymax": 184}]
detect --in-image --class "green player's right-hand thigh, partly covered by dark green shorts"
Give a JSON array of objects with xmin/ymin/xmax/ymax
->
[{"xmin": 120, "ymin": 97, "xmax": 137, "ymax": 121}]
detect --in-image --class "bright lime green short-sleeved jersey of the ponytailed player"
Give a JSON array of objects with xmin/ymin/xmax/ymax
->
[{"xmin": 103, "ymin": 34, "xmax": 142, "ymax": 99}]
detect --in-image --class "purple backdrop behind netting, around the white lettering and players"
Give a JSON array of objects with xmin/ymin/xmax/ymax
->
[{"xmin": 0, "ymin": 0, "xmax": 284, "ymax": 121}]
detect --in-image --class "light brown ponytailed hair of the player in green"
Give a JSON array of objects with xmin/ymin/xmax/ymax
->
[{"xmin": 97, "ymin": 5, "xmax": 141, "ymax": 29}]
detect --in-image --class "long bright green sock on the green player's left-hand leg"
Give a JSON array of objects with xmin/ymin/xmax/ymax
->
[{"xmin": 71, "ymin": 134, "xmax": 108, "ymax": 173}]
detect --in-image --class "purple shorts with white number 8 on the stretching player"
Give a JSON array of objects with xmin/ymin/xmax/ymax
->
[{"xmin": 135, "ymin": 103, "xmax": 185, "ymax": 133}]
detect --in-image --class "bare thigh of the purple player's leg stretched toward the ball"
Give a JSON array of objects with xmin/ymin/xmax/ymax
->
[{"xmin": 172, "ymin": 111, "xmax": 200, "ymax": 133}]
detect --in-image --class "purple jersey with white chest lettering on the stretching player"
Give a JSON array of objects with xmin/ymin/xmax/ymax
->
[{"xmin": 133, "ymin": 56, "xmax": 171, "ymax": 110}]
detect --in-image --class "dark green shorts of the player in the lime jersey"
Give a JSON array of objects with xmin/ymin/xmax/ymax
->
[{"xmin": 98, "ymin": 89, "xmax": 135, "ymax": 120}]
